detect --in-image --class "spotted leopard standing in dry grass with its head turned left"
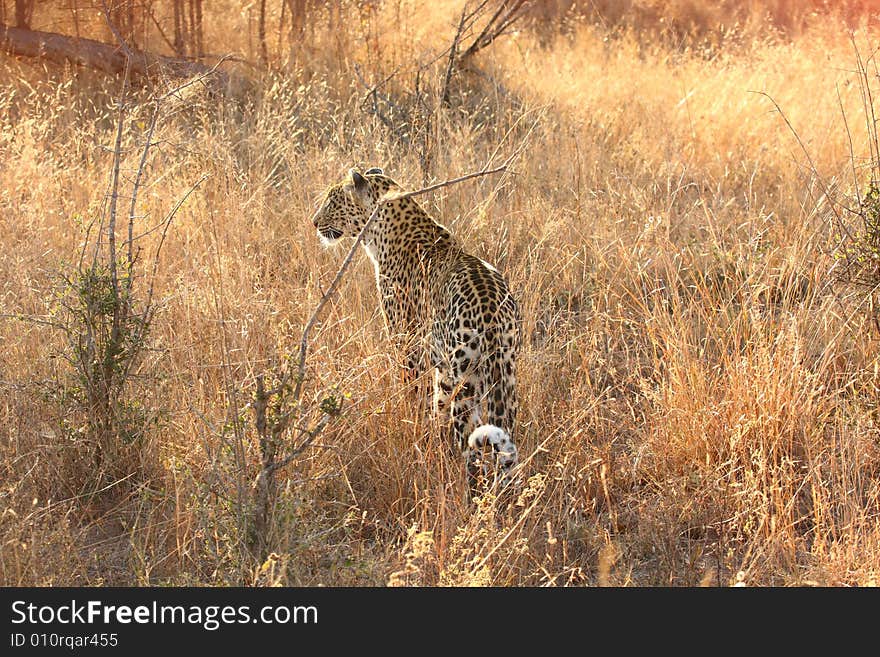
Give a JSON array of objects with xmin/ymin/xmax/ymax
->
[{"xmin": 312, "ymin": 167, "xmax": 522, "ymax": 497}]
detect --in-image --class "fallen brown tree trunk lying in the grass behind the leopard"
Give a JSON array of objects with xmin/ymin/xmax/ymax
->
[{"xmin": 0, "ymin": 24, "xmax": 222, "ymax": 78}]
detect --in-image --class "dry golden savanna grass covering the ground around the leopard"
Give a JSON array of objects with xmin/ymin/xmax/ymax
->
[{"xmin": 0, "ymin": 0, "xmax": 880, "ymax": 586}]
